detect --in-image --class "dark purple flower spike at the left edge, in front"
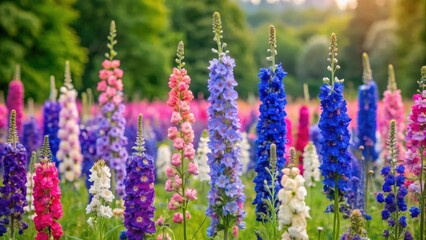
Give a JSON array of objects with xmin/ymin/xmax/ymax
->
[{"xmin": 0, "ymin": 110, "xmax": 28, "ymax": 239}]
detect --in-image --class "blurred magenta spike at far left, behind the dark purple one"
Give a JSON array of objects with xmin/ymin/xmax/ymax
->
[{"xmin": 7, "ymin": 65, "xmax": 24, "ymax": 136}]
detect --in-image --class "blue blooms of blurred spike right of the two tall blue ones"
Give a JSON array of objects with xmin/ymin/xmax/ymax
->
[{"xmin": 357, "ymin": 81, "xmax": 379, "ymax": 161}]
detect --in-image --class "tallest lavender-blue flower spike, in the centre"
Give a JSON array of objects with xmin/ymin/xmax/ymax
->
[{"xmin": 206, "ymin": 12, "xmax": 245, "ymax": 240}]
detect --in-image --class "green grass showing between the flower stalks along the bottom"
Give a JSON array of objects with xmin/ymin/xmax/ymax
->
[{"xmin": 3, "ymin": 172, "xmax": 418, "ymax": 240}]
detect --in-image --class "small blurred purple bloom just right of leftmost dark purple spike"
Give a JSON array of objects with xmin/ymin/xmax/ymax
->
[{"xmin": 22, "ymin": 116, "xmax": 42, "ymax": 166}]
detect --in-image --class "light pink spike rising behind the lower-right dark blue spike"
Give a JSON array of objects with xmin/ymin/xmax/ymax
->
[{"xmin": 380, "ymin": 64, "xmax": 405, "ymax": 162}]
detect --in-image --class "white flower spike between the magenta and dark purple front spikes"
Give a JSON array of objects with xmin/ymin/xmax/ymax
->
[{"xmin": 86, "ymin": 160, "xmax": 114, "ymax": 226}]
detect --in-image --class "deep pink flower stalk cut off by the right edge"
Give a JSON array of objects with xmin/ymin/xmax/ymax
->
[{"xmin": 405, "ymin": 66, "xmax": 426, "ymax": 240}]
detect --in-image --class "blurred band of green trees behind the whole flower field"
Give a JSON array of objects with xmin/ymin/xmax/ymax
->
[{"xmin": 0, "ymin": 0, "xmax": 426, "ymax": 102}]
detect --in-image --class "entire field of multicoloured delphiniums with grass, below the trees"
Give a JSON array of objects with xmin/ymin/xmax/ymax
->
[{"xmin": 0, "ymin": 12, "xmax": 426, "ymax": 240}]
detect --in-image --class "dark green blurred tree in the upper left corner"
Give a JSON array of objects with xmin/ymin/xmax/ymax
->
[{"xmin": 0, "ymin": 0, "xmax": 88, "ymax": 102}]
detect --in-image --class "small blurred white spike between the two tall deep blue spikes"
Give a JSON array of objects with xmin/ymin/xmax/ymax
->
[{"xmin": 303, "ymin": 142, "xmax": 321, "ymax": 187}]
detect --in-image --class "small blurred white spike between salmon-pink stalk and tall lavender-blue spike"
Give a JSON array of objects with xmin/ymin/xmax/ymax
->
[{"xmin": 194, "ymin": 130, "xmax": 210, "ymax": 181}]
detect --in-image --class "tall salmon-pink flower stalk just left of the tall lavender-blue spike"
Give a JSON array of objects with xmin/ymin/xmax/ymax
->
[{"xmin": 166, "ymin": 42, "xmax": 198, "ymax": 240}]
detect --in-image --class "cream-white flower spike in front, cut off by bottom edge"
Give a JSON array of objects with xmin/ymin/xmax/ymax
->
[{"xmin": 278, "ymin": 164, "xmax": 310, "ymax": 240}]
